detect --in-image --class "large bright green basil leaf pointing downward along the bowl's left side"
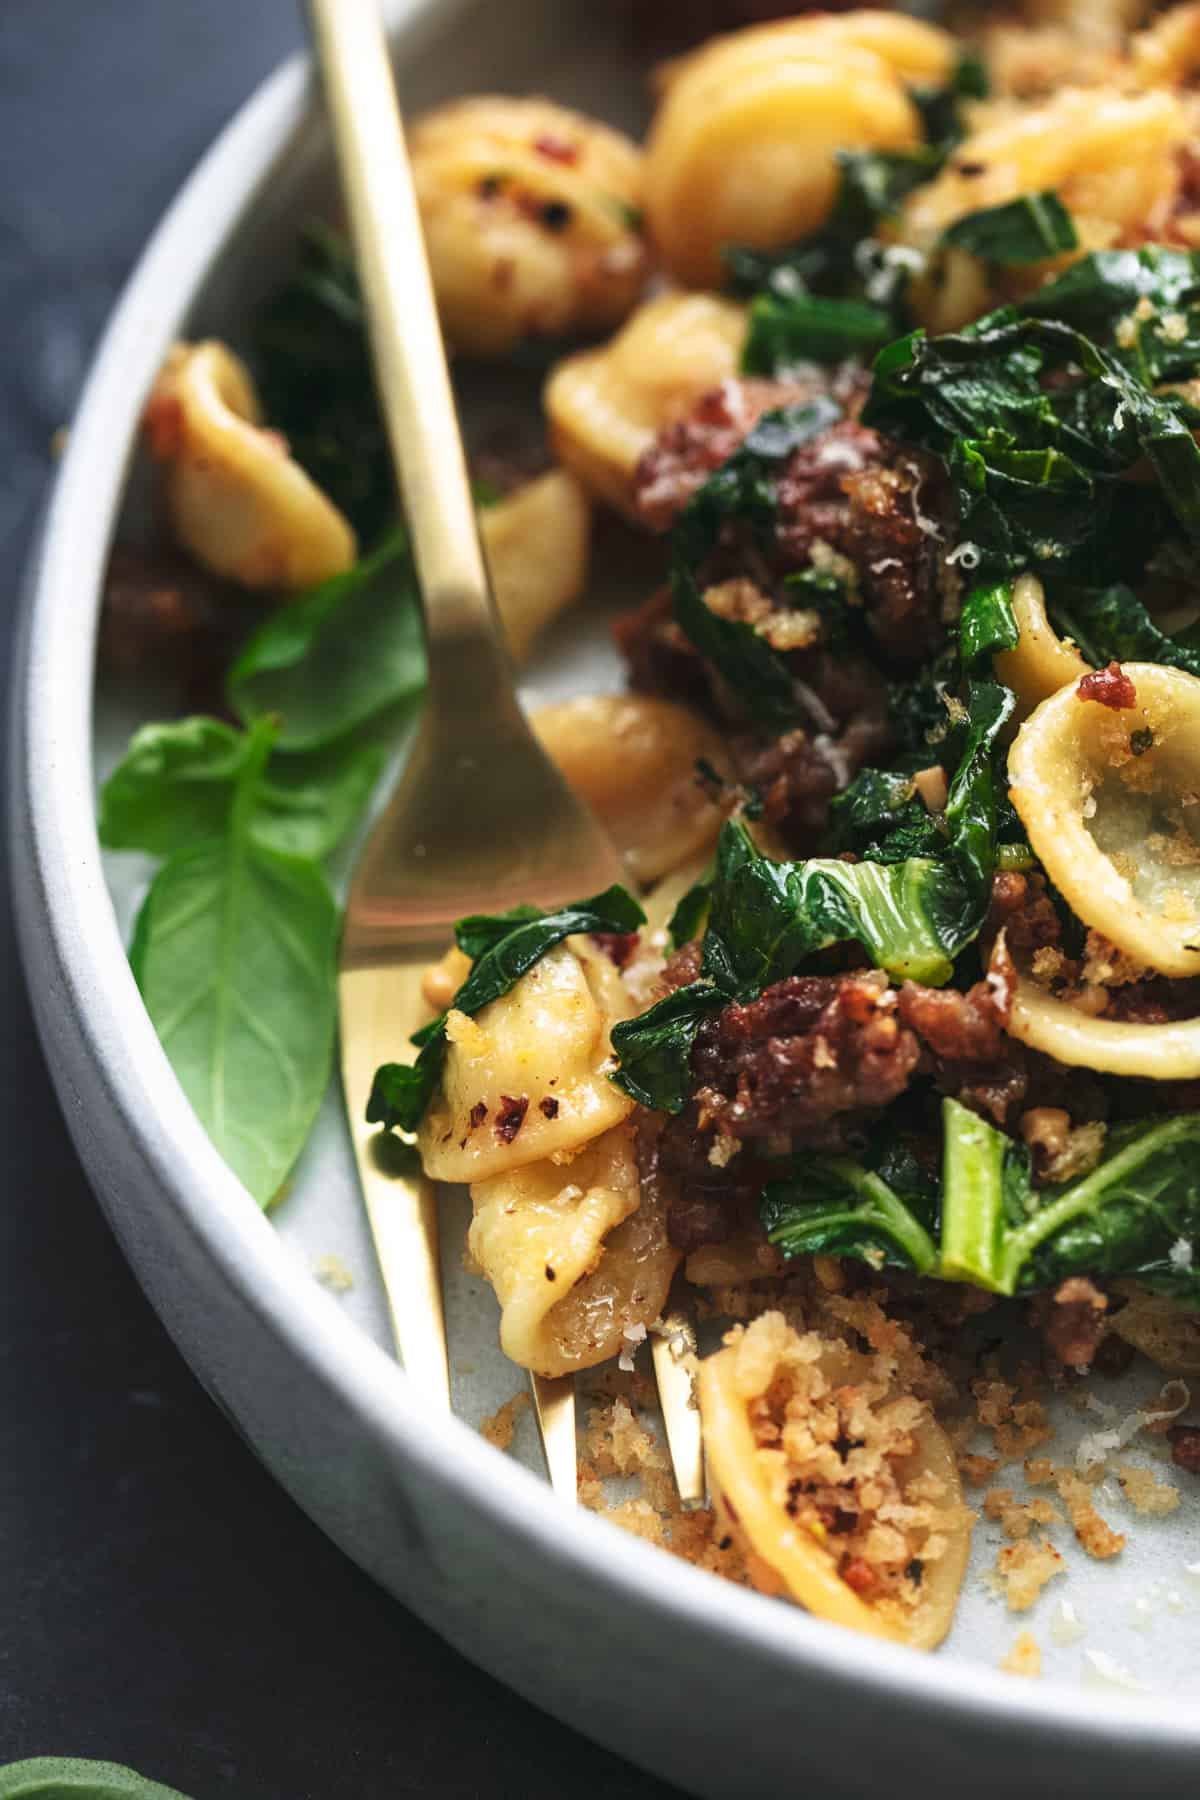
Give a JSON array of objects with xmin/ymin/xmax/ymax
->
[{"xmin": 130, "ymin": 742, "xmax": 338, "ymax": 1206}]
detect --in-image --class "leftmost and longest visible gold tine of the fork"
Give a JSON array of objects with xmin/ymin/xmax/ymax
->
[{"xmin": 338, "ymin": 965, "xmax": 450, "ymax": 1411}]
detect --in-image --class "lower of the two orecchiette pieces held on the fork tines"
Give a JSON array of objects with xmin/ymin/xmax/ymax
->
[{"xmin": 468, "ymin": 1121, "xmax": 680, "ymax": 1375}]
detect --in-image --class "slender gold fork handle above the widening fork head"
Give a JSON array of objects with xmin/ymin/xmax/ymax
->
[{"xmin": 308, "ymin": 0, "xmax": 511, "ymax": 698}]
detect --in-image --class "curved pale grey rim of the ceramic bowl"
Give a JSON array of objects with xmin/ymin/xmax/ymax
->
[{"xmin": 11, "ymin": 0, "xmax": 1200, "ymax": 1757}]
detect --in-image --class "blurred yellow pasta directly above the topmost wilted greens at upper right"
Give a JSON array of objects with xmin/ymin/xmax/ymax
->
[{"xmin": 900, "ymin": 86, "xmax": 1187, "ymax": 331}]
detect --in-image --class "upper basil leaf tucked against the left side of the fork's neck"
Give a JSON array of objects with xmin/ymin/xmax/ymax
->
[{"xmin": 228, "ymin": 529, "xmax": 425, "ymax": 751}]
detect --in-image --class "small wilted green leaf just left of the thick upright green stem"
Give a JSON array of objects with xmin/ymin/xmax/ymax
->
[{"xmin": 759, "ymin": 1156, "xmax": 937, "ymax": 1274}]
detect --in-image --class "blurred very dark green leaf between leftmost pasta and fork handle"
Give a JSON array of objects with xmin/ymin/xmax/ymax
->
[{"xmin": 254, "ymin": 223, "xmax": 396, "ymax": 544}]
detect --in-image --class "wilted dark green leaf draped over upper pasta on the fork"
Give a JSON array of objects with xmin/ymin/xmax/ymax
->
[{"xmin": 367, "ymin": 887, "xmax": 646, "ymax": 1132}]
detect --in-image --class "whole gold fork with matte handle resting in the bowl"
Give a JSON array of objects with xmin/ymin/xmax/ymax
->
[{"xmin": 309, "ymin": 0, "xmax": 702, "ymax": 1501}]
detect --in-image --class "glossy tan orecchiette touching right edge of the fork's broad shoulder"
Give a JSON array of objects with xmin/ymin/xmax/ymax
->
[{"xmin": 533, "ymin": 693, "xmax": 727, "ymax": 884}]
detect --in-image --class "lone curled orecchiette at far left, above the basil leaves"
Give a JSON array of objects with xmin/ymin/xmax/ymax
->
[{"xmin": 146, "ymin": 340, "xmax": 356, "ymax": 590}]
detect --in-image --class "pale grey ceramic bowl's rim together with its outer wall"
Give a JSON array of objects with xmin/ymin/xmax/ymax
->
[{"xmin": 11, "ymin": 0, "xmax": 1200, "ymax": 1800}]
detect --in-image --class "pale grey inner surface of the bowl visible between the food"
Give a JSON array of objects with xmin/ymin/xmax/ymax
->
[{"xmin": 84, "ymin": 0, "xmax": 1200, "ymax": 1696}]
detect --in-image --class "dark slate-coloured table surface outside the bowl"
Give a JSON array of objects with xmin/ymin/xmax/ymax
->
[{"xmin": 0, "ymin": 0, "xmax": 673, "ymax": 1800}]
